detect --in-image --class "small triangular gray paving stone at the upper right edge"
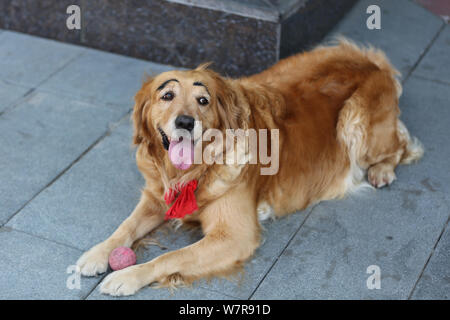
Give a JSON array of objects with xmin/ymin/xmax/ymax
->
[{"xmin": 414, "ymin": 25, "xmax": 450, "ymax": 84}]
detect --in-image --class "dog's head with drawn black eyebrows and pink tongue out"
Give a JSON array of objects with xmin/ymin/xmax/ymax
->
[{"xmin": 133, "ymin": 65, "xmax": 248, "ymax": 169}]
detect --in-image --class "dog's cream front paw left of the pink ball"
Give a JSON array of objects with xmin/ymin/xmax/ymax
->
[{"xmin": 77, "ymin": 243, "xmax": 111, "ymax": 277}]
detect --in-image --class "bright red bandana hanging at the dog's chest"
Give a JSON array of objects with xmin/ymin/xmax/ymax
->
[{"xmin": 164, "ymin": 180, "xmax": 198, "ymax": 220}]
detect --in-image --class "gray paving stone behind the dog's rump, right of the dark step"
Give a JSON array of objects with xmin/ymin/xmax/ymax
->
[{"xmin": 326, "ymin": 0, "xmax": 443, "ymax": 75}]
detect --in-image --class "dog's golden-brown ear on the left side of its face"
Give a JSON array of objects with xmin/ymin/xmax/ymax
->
[{"xmin": 132, "ymin": 78, "xmax": 153, "ymax": 144}]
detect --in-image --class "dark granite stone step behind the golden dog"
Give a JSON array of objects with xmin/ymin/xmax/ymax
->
[{"xmin": 0, "ymin": 0, "xmax": 355, "ymax": 76}]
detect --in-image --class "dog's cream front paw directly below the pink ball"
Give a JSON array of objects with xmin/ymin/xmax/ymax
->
[{"xmin": 100, "ymin": 266, "xmax": 145, "ymax": 296}]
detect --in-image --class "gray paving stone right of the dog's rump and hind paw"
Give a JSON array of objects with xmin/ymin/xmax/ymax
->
[{"xmin": 393, "ymin": 76, "xmax": 450, "ymax": 198}]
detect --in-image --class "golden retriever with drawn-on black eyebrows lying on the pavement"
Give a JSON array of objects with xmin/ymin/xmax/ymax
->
[{"xmin": 77, "ymin": 39, "xmax": 423, "ymax": 296}]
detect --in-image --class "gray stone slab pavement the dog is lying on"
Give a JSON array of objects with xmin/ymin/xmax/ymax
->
[{"xmin": 0, "ymin": 0, "xmax": 450, "ymax": 299}]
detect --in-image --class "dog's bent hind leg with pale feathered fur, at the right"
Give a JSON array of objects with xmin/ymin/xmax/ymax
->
[{"xmin": 338, "ymin": 71, "xmax": 423, "ymax": 188}]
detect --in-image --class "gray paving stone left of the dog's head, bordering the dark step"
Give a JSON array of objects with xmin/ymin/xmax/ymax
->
[{"xmin": 41, "ymin": 49, "xmax": 175, "ymax": 110}]
